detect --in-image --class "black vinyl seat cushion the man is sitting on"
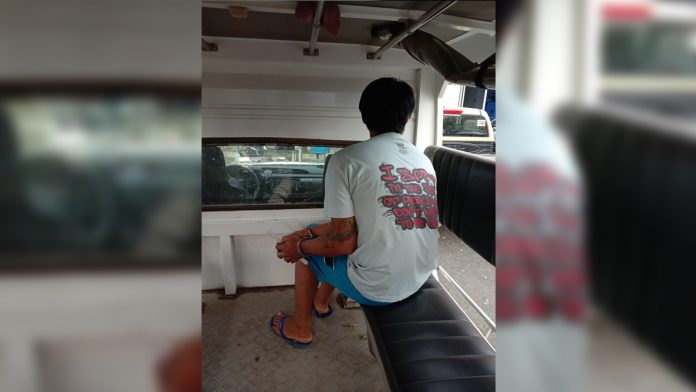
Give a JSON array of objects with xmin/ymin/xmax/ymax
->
[{"xmin": 362, "ymin": 277, "xmax": 495, "ymax": 392}]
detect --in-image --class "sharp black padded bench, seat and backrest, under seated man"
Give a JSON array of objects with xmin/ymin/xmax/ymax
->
[{"xmin": 362, "ymin": 147, "xmax": 495, "ymax": 392}]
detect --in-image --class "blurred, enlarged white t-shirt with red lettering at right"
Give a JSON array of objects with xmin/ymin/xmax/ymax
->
[{"xmin": 496, "ymin": 84, "xmax": 587, "ymax": 392}]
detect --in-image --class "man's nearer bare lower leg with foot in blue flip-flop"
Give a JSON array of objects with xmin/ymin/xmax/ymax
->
[{"xmin": 273, "ymin": 261, "xmax": 317, "ymax": 343}]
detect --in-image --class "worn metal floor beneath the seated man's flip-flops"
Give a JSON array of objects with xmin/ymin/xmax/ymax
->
[{"xmin": 202, "ymin": 287, "xmax": 388, "ymax": 392}]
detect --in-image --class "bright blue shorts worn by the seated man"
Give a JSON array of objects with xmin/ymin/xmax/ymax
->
[{"xmin": 305, "ymin": 224, "xmax": 390, "ymax": 306}]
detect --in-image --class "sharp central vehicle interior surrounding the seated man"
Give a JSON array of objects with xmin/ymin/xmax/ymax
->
[{"xmin": 202, "ymin": 1, "xmax": 496, "ymax": 391}]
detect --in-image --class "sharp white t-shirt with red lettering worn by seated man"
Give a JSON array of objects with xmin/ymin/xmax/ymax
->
[{"xmin": 324, "ymin": 132, "xmax": 438, "ymax": 302}]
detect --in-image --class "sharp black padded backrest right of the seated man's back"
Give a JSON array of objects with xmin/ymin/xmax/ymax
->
[{"xmin": 425, "ymin": 146, "xmax": 495, "ymax": 265}]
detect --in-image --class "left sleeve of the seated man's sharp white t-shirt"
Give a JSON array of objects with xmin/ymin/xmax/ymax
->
[{"xmin": 324, "ymin": 155, "xmax": 355, "ymax": 218}]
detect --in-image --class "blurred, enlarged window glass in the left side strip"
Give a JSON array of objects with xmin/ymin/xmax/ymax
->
[{"xmin": 0, "ymin": 93, "xmax": 201, "ymax": 267}]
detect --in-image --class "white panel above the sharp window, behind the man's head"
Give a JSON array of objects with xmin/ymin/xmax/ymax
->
[{"xmin": 203, "ymin": 76, "xmax": 418, "ymax": 141}]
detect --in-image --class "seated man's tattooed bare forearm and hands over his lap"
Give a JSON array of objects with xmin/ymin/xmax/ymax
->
[{"xmin": 276, "ymin": 217, "xmax": 358, "ymax": 262}]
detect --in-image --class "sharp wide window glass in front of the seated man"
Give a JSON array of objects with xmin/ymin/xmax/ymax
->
[{"xmin": 203, "ymin": 142, "xmax": 342, "ymax": 209}]
